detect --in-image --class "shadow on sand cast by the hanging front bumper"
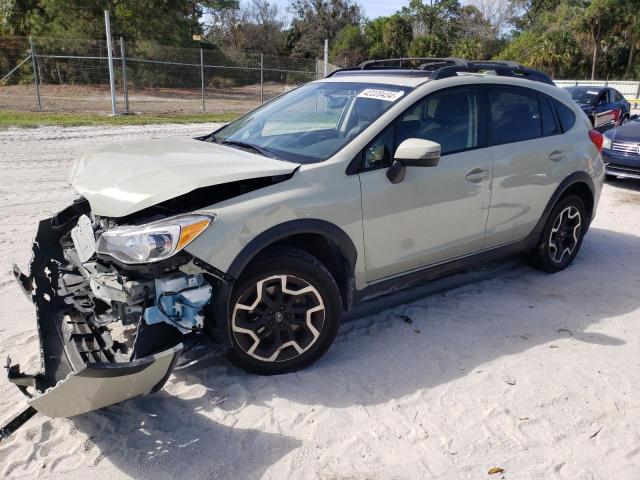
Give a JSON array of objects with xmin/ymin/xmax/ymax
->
[{"xmin": 72, "ymin": 391, "xmax": 302, "ymax": 480}]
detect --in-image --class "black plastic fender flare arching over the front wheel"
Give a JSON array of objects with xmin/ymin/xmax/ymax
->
[{"xmin": 227, "ymin": 218, "xmax": 358, "ymax": 279}]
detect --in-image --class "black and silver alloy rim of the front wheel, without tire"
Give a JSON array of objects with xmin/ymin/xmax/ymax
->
[{"xmin": 231, "ymin": 275, "xmax": 324, "ymax": 362}]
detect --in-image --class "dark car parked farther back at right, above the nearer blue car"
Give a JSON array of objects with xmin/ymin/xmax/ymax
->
[{"xmin": 566, "ymin": 86, "xmax": 631, "ymax": 132}]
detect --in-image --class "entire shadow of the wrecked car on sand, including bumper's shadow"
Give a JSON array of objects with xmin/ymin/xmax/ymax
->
[{"xmin": 73, "ymin": 229, "xmax": 640, "ymax": 479}]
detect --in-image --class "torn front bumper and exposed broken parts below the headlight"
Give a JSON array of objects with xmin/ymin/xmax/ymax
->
[{"xmin": 7, "ymin": 199, "xmax": 217, "ymax": 417}]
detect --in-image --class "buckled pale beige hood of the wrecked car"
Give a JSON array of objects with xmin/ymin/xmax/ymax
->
[{"xmin": 70, "ymin": 139, "xmax": 298, "ymax": 218}]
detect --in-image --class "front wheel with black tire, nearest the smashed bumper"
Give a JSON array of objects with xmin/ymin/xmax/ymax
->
[{"xmin": 229, "ymin": 248, "xmax": 342, "ymax": 375}]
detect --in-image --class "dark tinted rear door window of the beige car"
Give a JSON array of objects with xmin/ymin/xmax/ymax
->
[{"xmin": 489, "ymin": 88, "xmax": 542, "ymax": 145}]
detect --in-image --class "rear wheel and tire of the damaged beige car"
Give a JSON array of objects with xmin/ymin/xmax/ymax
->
[{"xmin": 524, "ymin": 195, "xmax": 588, "ymax": 273}]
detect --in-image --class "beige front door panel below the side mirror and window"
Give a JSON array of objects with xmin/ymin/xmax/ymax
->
[{"xmin": 360, "ymin": 148, "xmax": 492, "ymax": 282}]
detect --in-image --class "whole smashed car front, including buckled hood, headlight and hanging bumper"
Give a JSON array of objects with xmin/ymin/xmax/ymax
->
[{"xmin": 0, "ymin": 138, "xmax": 299, "ymax": 422}]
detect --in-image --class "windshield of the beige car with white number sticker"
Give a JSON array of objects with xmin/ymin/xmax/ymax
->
[{"xmin": 213, "ymin": 82, "xmax": 411, "ymax": 163}]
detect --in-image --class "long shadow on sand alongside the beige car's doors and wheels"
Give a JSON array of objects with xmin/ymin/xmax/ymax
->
[{"xmin": 177, "ymin": 229, "xmax": 640, "ymax": 410}]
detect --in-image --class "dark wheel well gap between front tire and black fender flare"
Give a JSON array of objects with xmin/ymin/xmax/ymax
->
[{"xmin": 256, "ymin": 233, "xmax": 353, "ymax": 310}]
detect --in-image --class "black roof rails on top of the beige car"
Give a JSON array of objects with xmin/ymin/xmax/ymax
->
[{"xmin": 328, "ymin": 57, "xmax": 554, "ymax": 85}]
